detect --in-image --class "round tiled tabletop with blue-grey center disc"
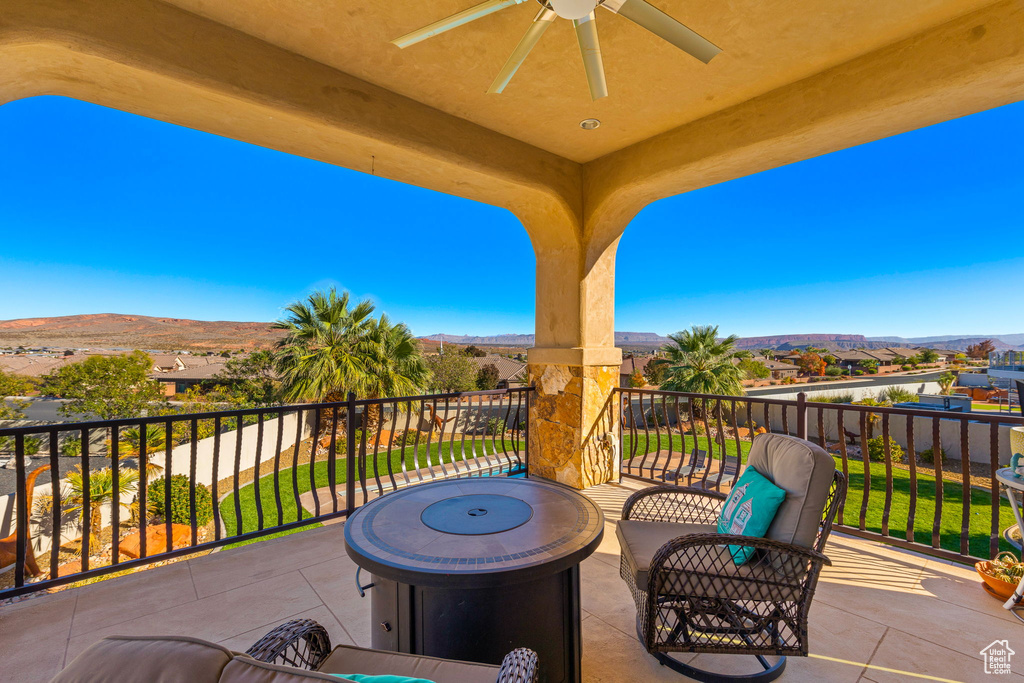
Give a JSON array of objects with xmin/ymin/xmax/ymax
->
[{"xmin": 345, "ymin": 477, "xmax": 604, "ymax": 588}]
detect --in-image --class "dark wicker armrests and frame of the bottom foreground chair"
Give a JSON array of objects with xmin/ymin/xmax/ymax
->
[{"xmin": 246, "ymin": 618, "xmax": 538, "ymax": 683}]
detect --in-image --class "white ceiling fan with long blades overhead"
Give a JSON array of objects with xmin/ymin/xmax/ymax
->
[{"xmin": 391, "ymin": 0, "xmax": 722, "ymax": 99}]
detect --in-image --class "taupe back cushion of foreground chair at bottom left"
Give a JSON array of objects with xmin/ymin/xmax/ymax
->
[{"xmin": 53, "ymin": 636, "xmax": 232, "ymax": 683}]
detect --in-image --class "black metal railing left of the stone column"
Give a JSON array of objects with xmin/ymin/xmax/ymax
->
[{"xmin": 0, "ymin": 387, "xmax": 532, "ymax": 597}]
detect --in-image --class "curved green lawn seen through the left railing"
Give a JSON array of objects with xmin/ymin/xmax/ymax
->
[{"xmin": 220, "ymin": 439, "xmax": 525, "ymax": 547}]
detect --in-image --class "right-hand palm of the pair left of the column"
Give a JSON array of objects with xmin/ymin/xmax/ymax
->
[{"xmin": 356, "ymin": 314, "xmax": 430, "ymax": 433}]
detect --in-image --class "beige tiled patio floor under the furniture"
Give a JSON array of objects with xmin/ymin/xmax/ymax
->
[{"xmin": 0, "ymin": 481, "xmax": 1024, "ymax": 683}]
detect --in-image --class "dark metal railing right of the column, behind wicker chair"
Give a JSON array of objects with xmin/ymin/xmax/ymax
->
[{"xmin": 612, "ymin": 389, "xmax": 1024, "ymax": 562}]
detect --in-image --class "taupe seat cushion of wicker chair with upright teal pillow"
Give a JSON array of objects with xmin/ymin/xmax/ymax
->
[{"xmin": 615, "ymin": 519, "xmax": 802, "ymax": 601}]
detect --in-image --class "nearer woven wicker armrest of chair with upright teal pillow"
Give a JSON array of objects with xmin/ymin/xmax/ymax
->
[{"xmin": 648, "ymin": 533, "xmax": 831, "ymax": 599}]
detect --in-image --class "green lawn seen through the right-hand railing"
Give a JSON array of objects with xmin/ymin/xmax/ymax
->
[{"xmin": 623, "ymin": 433, "xmax": 1014, "ymax": 558}]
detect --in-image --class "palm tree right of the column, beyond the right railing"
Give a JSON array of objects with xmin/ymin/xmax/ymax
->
[{"xmin": 651, "ymin": 325, "xmax": 743, "ymax": 396}]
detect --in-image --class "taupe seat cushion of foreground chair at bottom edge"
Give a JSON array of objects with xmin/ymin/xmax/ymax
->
[{"xmin": 319, "ymin": 645, "xmax": 501, "ymax": 683}]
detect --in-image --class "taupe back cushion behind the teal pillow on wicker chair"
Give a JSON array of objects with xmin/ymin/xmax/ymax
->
[{"xmin": 746, "ymin": 434, "xmax": 836, "ymax": 548}]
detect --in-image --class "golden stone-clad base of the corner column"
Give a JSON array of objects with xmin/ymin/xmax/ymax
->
[{"xmin": 528, "ymin": 362, "xmax": 620, "ymax": 488}]
